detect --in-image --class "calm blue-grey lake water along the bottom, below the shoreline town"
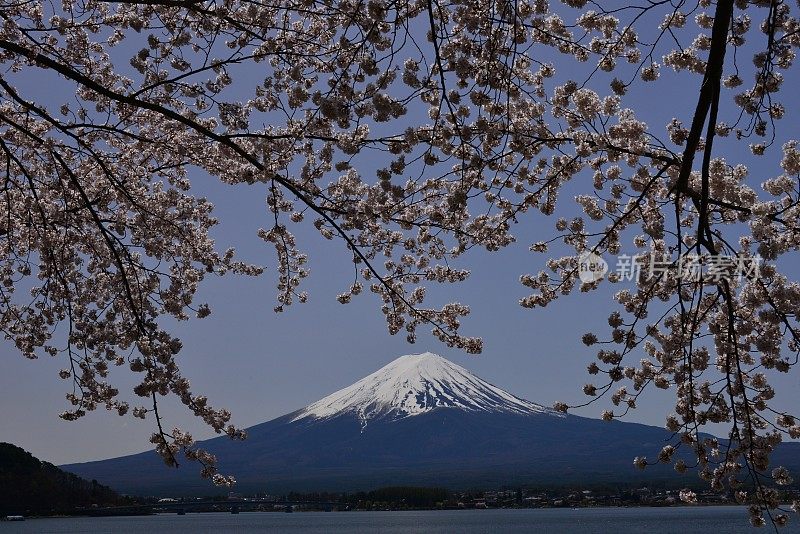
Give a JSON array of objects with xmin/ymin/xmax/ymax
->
[{"xmin": 0, "ymin": 506, "xmax": 800, "ymax": 534}]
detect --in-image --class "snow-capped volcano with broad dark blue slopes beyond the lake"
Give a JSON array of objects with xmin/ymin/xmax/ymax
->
[{"xmin": 62, "ymin": 353, "xmax": 800, "ymax": 496}]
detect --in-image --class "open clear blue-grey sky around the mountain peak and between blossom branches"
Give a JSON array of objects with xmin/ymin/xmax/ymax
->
[{"xmin": 0, "ymin": 4, "xmax": 800, "ymax": 464}]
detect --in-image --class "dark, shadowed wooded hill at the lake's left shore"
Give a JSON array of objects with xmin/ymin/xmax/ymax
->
[{"xmin": 0, "ymin": 443, "xmax": 123, "ymax": 516}]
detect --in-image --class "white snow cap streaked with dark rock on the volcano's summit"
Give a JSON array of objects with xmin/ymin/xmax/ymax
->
[{"xmin": 293, "ymin": 352, "xmax": 554, "ymax": 425}]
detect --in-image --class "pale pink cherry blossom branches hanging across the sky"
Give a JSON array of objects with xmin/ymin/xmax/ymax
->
[{"xmin": 0, "ymin": 0, "xmax": 800, "ymax": 525}]
